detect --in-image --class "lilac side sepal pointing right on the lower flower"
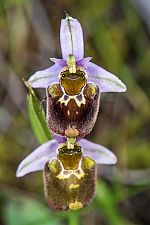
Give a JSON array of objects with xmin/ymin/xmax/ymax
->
[{"xmin": 79, "ymin": 139, "xmax": 117, "ymax": 164}]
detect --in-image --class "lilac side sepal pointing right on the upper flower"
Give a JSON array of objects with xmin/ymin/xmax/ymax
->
[{"xmin": 85, "ymin": 62, "xmax": 127, "ymax": 92}]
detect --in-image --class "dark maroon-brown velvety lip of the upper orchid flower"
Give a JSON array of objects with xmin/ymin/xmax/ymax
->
[{"xmin": 47, "ymin": 67, "xmax": 100, "ymax": 137}]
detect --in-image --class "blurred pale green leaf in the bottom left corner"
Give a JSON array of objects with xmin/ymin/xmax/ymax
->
[{"xmin": 3, "ymin": 192, "xmax": 60, "ymax": 225}]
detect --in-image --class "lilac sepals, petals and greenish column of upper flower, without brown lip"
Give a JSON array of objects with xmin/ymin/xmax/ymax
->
[{"xmin": 28, "ymin": 15, "xmax": 126, "ymax": 92}]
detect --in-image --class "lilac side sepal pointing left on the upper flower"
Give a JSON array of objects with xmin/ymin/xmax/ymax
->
[{"xmin": 28, "ymin": 64, "xmax": 62, "ymax": 88}]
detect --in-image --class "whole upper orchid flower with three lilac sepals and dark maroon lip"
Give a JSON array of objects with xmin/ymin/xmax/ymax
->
[{"xmin": 28, "ymin": 15, "xmax": 126, "ymax": 137}]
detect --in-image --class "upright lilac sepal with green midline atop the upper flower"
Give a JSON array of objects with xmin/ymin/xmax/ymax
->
[{"xmin": 60, "ymin": 16, "xmax": 84, "ymax": 60}]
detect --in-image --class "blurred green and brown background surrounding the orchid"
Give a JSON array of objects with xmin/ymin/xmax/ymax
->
[{"xmin": 0, "ymin": 0, "xmax": 150, "ymax": 225}]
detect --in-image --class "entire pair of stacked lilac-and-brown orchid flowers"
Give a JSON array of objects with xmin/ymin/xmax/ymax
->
[{"xmin": 17, "ymin": 15, "xmax": 126, "ymax": 210}]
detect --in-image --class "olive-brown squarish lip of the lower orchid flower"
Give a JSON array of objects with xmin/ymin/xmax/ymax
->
[{"xmin": 44, "ymin": 146, "xmax": 96, "ymax": 210}]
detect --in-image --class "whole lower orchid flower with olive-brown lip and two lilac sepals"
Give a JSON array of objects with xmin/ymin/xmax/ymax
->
[{"xmin": 16, "ymin": 136, "xmax": 117, "ymax": 210}]
